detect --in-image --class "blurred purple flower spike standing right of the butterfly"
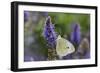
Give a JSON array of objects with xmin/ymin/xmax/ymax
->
[{"xmin": 71, "ymin": 24, "xmax": 81, "ymax": 45}]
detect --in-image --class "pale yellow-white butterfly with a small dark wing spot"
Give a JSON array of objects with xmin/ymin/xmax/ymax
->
[{"xmin": 56, "ymin": 35, "xmax": 75, "ymax": 59}]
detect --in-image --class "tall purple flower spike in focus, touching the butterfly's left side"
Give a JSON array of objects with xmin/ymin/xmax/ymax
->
[{"xmin": 43, "ymin": 16, "xmax": 57, "ymax": 48}]
